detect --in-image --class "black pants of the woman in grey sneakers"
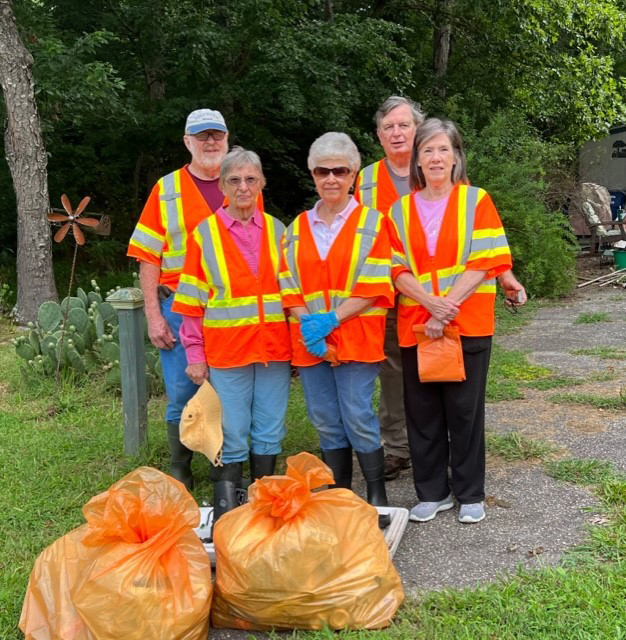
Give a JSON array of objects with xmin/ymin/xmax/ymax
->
[{"xmin": 402, "ymin": 336, "xmax": 491, "ymax": 504}]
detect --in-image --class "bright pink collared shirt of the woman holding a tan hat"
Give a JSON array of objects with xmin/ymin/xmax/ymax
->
[{"xmin": 179, "ymin": 207, "xmax": 263, "ymax": 364}]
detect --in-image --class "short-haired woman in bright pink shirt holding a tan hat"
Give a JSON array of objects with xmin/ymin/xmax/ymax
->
[{"xmin": 173, "ymin": 147, "xmax": 291, "ymax": 522}]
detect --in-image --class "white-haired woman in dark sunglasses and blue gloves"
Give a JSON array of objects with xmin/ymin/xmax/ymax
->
[{"xmin": 280, "ymin": 132, "xmax": 394, "ymax": 526}]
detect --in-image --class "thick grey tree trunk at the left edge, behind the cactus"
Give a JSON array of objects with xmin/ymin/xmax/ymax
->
[{"xmin": 0, "ymin": 0, "xmax": 57, "ymax": 322}]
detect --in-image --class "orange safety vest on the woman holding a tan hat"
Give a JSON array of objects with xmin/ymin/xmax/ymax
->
[{"xmin": 172, "ymin": 213, "xmax": 291, "ymax": 368}]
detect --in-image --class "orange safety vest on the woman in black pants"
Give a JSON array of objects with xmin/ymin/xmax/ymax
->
[{"xmin": 389, "ymin": 184, "xmax": 511, "ymax": 347}]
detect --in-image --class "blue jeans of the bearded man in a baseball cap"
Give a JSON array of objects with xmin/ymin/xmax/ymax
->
[{"xmin": 159, "ymin": 295, "xmax": 198, "ymax": 424}]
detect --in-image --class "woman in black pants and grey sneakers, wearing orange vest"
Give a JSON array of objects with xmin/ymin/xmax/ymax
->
[{"xmin": 390, "ymin": 118, "xmax": 511, "ymax": 523}]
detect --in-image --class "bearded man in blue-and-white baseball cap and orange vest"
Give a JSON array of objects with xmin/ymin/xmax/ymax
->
[{"xmin": 128, "ymin": 109, "xmax": 234, "ymax": 489}]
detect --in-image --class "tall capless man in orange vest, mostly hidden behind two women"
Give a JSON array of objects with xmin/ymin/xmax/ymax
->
[{"xmin": 354, "ymin": 96, "xmax": 526, "ymax": 480}]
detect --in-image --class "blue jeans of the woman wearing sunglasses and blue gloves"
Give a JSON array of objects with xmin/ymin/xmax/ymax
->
[{"xmin": 298, "ymin": 362, "xmax": 381, "ymax": 453}]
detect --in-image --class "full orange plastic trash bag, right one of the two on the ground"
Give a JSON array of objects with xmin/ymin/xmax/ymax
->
[{"xmin": 211, "ymin": 453, "xmax": 404, "ymax": 631}]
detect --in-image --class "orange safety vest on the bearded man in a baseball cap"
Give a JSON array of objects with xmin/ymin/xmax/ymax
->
[{"xmin": 126, "ymin": 165, "xmax": 263, "ymax": 290}]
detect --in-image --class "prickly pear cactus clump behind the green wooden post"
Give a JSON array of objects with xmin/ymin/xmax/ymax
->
[{"xmin": 13, "ymin": 280, "xmax": 162, "ymax": 394}]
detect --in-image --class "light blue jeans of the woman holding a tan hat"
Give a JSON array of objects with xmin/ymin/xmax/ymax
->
[{"xmin": 209, "ymin": 362, "xmax": 291, "ymax": 463}]
